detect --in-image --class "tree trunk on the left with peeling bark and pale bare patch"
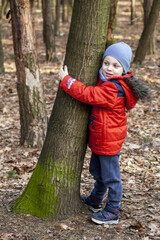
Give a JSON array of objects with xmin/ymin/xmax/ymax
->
[{"xmin": 10, "ymin": 0, "xmax": 47, "ymax": 146}]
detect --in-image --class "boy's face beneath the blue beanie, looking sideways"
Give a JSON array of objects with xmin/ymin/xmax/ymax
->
[{"xmin": 102, "ymin": 56, "xmax": 123, "ymax": 79}]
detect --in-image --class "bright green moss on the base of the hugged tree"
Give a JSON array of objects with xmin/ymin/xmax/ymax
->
[{"xmin": 12, "ymin": 158, "xmax": 78, "ymax": 218}]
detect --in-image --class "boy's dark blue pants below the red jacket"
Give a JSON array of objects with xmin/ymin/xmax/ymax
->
[{"xmin": 89, "ymin": 153, "xmax": 122, "ymax": 206}]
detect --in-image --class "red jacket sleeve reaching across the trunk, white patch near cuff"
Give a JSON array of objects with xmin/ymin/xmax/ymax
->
[{"xmin": 60, "ymin": 75, "xmax": 118, "ymax": 108}]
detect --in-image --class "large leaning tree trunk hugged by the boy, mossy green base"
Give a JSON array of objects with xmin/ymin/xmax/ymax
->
[{"xmin": 13, "ymin": 0, "xmax": 110, "ymax": 218}]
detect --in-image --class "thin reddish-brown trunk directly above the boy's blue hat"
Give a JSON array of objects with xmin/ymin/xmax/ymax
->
[{"xmin": 106, "ymin": 0, "xmax": 118, "ymax": 48}]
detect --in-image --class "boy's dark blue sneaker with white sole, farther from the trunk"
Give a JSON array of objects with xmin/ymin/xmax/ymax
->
[{"xmin": 91, "ymin": 203, "xmax": 120, "ymax": 224}]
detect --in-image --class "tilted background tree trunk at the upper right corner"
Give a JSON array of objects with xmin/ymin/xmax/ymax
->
[{"xmin": 134, "ymin": 0, "xmax": 160, "ymax": 63}]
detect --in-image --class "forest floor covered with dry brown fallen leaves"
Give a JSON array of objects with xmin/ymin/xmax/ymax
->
[{"xmin": 0, "ymin": 1, "xmax": 160, "ymax": 240}]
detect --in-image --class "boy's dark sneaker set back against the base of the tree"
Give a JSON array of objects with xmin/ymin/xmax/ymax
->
[{"xmin": 81, "ymin": 195, "xmax": 102, "ymax": 213}]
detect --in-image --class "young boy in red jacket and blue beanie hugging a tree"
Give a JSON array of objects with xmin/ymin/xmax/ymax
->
[{"xmin": 59, "ymin": 42, "xmax": 149, "ymax": 224}]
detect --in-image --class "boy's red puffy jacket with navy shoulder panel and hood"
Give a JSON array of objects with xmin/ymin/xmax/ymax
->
[{"xmin": 60, "ymin": 73, "xmax": 138, "ymax": 155}]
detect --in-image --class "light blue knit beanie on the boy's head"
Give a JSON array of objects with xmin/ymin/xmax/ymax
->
[{"xmin": 103, "ymin": 42, "xmax": 132, "ymax": 73}]
